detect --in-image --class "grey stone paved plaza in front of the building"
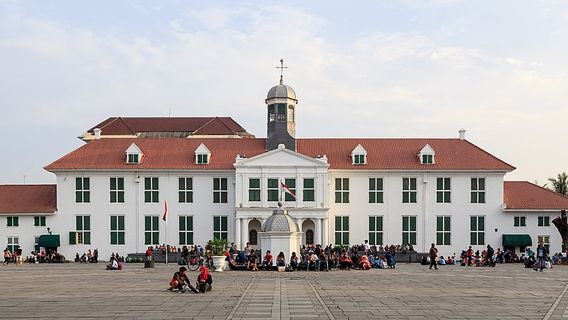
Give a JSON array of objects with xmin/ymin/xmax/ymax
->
[{"xmin": 0, "ymin": 263, "xmax": 568, "ymax": 319}]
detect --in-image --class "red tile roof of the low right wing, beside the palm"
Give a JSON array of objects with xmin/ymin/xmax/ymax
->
[{"xmin": 503, "ymin": 181, "xmax": 568, "ymax": 210}]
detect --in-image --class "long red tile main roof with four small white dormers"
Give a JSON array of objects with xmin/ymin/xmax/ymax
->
[{"xmin": 45, "ymin": 138, "xmax": 515, "ymax": 171}]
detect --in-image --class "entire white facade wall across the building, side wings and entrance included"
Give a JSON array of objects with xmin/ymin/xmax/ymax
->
[{"xmin": 36, "ymin": 162, "xmax": 561, "ymax": 259}]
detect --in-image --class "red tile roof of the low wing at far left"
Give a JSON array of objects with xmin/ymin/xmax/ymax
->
[{"xmin": 0, "ymin": 184, "xmax": 57, "ymax": 214}]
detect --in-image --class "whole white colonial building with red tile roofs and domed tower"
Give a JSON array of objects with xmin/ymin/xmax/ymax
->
[{"xmin": 0, "ymin": 75, "xmax": 568, "ymax": 258}]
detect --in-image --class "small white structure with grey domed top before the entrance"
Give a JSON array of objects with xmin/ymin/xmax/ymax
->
[{"xmin": 259, "ymin": 203, "xmax": 302, "ymax": 261}]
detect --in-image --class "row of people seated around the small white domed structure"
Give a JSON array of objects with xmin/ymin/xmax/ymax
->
[{"xmin": 225, "ymin": 245, "xmax": 400, "ymax": 271}]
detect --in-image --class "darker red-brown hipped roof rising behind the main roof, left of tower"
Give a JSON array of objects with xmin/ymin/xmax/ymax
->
[{"xmin": 87, "ymin": 117, "xmax": 246, "ymax": 135}]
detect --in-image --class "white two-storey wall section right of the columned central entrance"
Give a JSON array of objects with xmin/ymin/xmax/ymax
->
[{"xmin": 328, "ymin": 170, "xmax": 504, "ymax": 255}]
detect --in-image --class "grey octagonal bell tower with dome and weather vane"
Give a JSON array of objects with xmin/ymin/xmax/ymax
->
[{"xmin": 264, "ymin": 59, "xmax": 298, "ymax": 151}]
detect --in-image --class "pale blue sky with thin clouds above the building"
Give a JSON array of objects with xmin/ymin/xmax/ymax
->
[{"xmin": 0, "ymin": 0, "xmax": 568, "ymax": 185}]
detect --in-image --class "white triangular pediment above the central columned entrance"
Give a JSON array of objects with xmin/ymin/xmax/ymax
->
[{"xmin": 235, "ymin": 148, "xmax": 329, "ymax": 168}]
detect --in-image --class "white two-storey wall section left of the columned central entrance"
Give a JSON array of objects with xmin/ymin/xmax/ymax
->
[{"xmin": 49, "ymin": 171, "xmax": 235, "ymax": 259}]
